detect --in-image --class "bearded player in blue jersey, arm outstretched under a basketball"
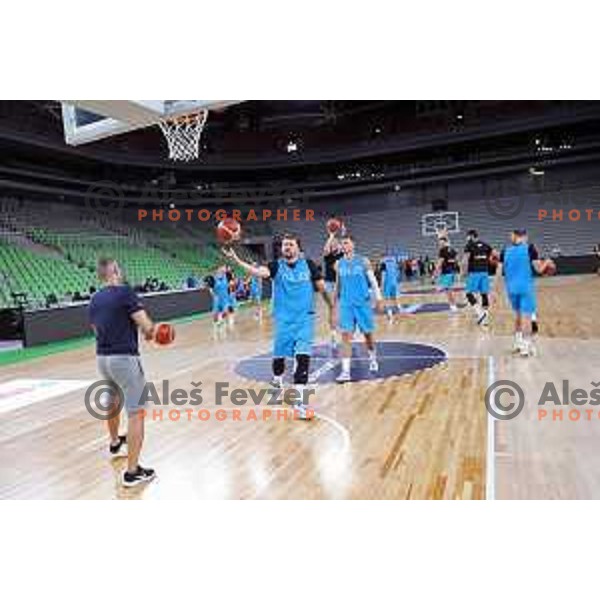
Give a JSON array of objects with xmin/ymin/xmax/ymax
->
[{"xmin": 223, "ymin": 234, "xmax": 332, "ymax": 419}]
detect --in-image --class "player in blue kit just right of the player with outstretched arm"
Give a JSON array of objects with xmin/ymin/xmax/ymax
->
[{"xmin": 335, "ymin": 234, "xmax": 383, "ymax": 383}]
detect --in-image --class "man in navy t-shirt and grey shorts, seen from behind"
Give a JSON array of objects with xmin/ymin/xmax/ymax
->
[{"xmin": 89, "ymin": 258, "xmax": 155, "ymax": 487}]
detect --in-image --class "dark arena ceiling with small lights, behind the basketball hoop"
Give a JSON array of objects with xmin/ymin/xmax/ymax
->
[{"xmin": 0, "ymin": 100, "xmax": 600, "ymax": 207}]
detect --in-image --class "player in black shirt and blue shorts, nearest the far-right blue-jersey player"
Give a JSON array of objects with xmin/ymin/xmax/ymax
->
[{"xmin": 465, "ymin": 229, "xmax": 492, "ymax": 325}]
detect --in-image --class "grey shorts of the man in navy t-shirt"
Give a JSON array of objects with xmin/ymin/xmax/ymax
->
[{"xmin": 97, "ymin": 354, "xmax": 146, "ymax": 414}]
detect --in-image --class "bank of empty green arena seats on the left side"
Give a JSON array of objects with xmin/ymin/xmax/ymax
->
[{"xmin": 0, "ymin": 199, "xmax": 234, "ymax": 307}]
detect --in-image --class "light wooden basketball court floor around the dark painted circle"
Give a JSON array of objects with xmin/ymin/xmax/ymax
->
[{"xmin": 0, "ymin": 276, "xmax": 600, "ymax": 499}]
